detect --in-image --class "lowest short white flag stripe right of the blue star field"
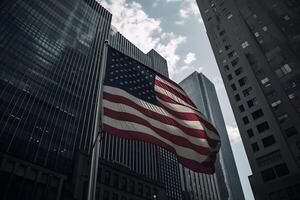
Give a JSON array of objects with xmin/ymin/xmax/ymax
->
[{"xmin": 157, "ymin": 97, "xmax": 220, "ymax": 140}]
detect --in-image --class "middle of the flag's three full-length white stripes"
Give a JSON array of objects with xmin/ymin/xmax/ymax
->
[{"xmin": 103, "ymin": 99, "xmax": 210, "ymax": 148}]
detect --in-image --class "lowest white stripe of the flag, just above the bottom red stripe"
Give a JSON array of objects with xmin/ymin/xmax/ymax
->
[{"xmin": 103, "ymin": 116, "xmax": 208, "ymax": 163}]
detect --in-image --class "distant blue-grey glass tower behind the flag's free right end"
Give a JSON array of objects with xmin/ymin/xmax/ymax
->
[{"xmin": 179, "ymin": 72, "xmax": 233, "ymax": 199}]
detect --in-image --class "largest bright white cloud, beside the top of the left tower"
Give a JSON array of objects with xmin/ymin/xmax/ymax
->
[{"xmin": 98, "ymin": 0, "xmax": 186, "ymax": 77}]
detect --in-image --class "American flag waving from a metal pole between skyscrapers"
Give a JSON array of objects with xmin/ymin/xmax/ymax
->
[{"xmin": 102, "ymin": 47, "xmax": 220, "ymax": 174}]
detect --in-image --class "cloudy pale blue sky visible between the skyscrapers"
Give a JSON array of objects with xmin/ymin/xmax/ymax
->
[{"xmin": 98, "ymin": 0, "xmax": 254, "ymax": 200}]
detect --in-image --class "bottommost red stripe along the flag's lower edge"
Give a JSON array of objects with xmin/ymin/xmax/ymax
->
[{"xmin": 103, "ymin": 124, "xmax": 214, "ymax": 174}]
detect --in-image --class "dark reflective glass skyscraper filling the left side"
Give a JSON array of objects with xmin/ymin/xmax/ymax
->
[{"xmin": 0, "ymin": 0, "xmax": 111, "ymax": 199}]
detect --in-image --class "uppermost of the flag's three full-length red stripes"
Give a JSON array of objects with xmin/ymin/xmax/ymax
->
[{"xmin": 103, "ymin": 92, "xmax": 219, "ymax": 148}]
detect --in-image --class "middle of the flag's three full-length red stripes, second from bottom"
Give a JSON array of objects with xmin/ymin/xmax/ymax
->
[{"xmin": 104, "ymin": 108, "xmax": 209, "ymax": 155}]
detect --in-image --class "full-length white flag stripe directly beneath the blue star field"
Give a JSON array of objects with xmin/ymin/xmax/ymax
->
[{"xmin": 103, "ymin": 85, "xmax": 203, "ymax": 130}]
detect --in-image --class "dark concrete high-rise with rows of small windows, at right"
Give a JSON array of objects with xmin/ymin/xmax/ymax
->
[{"xmin": 197, "ymin": 0, "xmax": 300, "ymax": 200}]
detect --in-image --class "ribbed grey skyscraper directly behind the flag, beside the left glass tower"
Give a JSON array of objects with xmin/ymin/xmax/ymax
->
[{"xmin": 100, "ymin": 27, "xmax": 181, "ymax": 200}]
